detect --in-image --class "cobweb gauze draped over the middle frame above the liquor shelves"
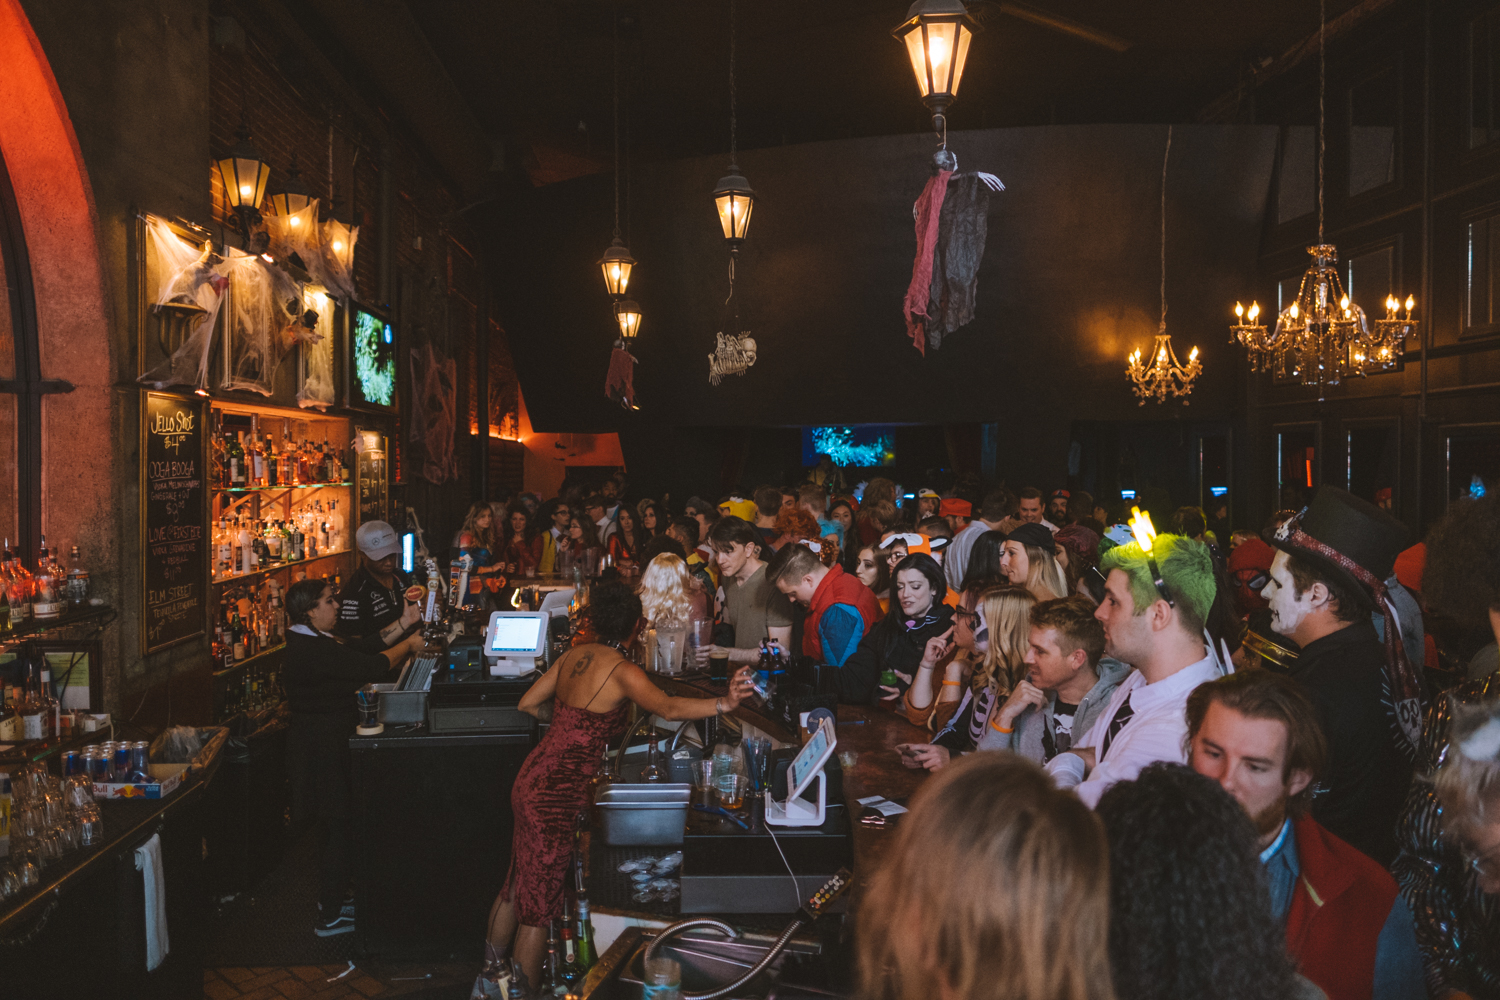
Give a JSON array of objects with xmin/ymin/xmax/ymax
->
[{"xmin": 222, "ymin": 249, "xmax": 311, "ymax": 396}]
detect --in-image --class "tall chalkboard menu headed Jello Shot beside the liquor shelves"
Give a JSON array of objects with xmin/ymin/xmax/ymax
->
[{"xmin": 141, "ymin": 393, "xmax": 209, "ymax": 652}]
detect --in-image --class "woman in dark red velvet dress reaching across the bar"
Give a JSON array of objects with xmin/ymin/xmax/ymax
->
[{"xmin": 485, "ymin": 582, "xmax": 750, "ymax": 985}]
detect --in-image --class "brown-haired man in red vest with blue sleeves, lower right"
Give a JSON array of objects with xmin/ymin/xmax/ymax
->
[{"xmin": 1187, "ymin": 669, "xmax": 1427, "ymax": 1000}]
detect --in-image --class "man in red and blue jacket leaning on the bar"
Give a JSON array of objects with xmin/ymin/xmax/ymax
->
[{"xmin": 765, "ymin": 541, "xmax": 881, "ymax": 667}]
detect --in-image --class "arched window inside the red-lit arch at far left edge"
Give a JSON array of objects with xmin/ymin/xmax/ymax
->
[{"xmin": 0, "ymin": 143, "xmax": 45, "ymax": 562}]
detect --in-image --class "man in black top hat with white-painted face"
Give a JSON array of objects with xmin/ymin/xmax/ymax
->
[{"xmin": 1262, "ymin": 486, "xmax": 1422, "ymax": 865}]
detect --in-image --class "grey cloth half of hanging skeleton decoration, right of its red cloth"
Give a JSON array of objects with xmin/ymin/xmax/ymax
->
[{"xmin": 924, "ymin": 174, "xmax": 1005, "ymax": 351}]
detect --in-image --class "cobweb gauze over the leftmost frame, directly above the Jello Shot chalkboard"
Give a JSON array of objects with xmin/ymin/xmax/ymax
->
[{"xmin": 137, "ymin": 216, "xmax": 231, "ymax": 388}]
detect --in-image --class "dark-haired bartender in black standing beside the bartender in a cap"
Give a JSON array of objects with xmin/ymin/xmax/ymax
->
[{"xmin": 284, "ymin": 580, "xmax": 422, "ymax": 937}]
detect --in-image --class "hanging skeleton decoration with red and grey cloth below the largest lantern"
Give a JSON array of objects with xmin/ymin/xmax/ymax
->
[{"xmin": 902, "ymin": 164, "xmax": 1005, "ymax": 355}]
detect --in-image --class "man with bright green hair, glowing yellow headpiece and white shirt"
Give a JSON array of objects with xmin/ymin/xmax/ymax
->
[{"xmin": 1047, "ymin": 522, "xmax": 1223, "ymax": 808}]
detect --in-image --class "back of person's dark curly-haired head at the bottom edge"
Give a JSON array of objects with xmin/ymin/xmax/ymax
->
[{"xmin": 1095, "ymin": 763, "xmax": 1322, "ymax": 1000}]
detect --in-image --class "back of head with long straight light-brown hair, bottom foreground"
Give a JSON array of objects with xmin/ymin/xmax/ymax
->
[{"xmin": 857, "ymin": 754, "xmax": 1115, "ymax": 1000}]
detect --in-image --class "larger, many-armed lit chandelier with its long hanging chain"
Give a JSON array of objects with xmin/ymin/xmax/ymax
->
[{"xmin": 1230, "ymin": 1, "xmax": 1416, "ymax": 399}]
